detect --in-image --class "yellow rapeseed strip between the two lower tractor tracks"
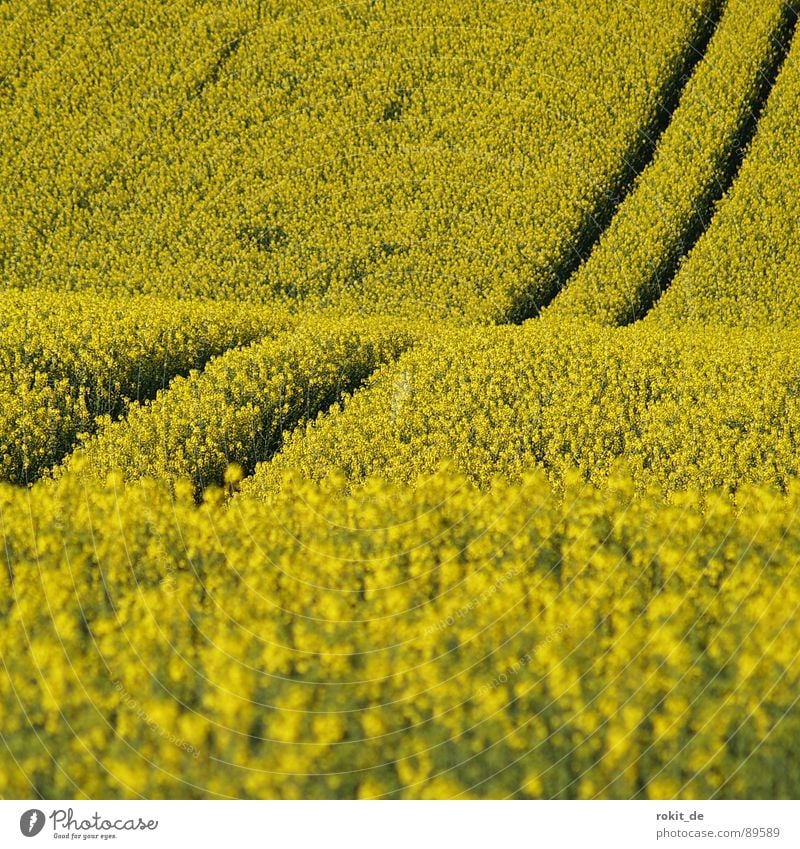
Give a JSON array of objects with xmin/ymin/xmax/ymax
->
[{"xmin": 57, "ymin": 318, "xmax": 432, "ymax": 497}]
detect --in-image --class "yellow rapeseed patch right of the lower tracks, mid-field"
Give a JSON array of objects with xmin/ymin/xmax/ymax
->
[{"xmin": 244, "ymin": 321, "xmax": 800, "ymax": 496}]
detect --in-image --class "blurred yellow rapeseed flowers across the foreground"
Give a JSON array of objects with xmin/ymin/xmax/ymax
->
[{"xmin": 0, "ymin": 470, "xmax": 800, "ymax": 798}]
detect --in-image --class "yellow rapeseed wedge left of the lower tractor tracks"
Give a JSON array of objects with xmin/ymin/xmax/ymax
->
[{"xmin": 0, "ymin": 290, "xmax": 296, "ymax": 483}]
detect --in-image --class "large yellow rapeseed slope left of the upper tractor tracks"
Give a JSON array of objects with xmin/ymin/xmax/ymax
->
[{"xmin": 0, "ymin": 0, "xmax": 721, "ymax": 319}]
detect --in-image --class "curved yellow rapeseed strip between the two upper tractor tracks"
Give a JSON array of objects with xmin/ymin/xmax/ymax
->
[{"xmin": 543, "ymin": 0, "xmax": 796, "ymax": 325}]
